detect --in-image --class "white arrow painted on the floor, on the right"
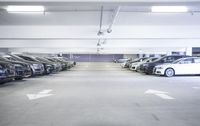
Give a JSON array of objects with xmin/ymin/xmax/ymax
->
[{"xmin": 145, "ymin": 89, "xmax": 175, "ymax": 99}]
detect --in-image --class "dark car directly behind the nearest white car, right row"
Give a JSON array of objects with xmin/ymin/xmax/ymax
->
[{"xmin": 140, "ymin": 55, "xmax": 189, "ymax": 74}]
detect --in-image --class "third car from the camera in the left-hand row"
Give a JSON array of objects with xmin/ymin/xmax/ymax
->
[{"xmin": 3, "ymin": 54, "xmax": 44, "ymax": 76}]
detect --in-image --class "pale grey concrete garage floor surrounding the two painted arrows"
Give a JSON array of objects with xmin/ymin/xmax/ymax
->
[{"xmin": 0, "ymin": 63, "xmax": 200, "ymax": 126}]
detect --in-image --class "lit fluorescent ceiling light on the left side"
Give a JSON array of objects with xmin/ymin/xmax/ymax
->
[{"xmin": 6, "ymin": 5, "xmax": 45, "ymax": 13}]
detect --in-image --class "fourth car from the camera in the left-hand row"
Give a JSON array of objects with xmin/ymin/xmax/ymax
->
[{"xmin": 17, "ymin": 54, "xmax": 53, "ymax": 74}]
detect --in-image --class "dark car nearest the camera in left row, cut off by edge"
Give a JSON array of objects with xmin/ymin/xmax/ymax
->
[{"xmin": 0, "ymin": 61, "xmax": 15, "ymax": 83}]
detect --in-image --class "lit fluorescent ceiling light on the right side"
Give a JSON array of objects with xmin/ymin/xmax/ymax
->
[{"xmin": 151, "ymin": 6, "xmax": 188, "ymax": 13}]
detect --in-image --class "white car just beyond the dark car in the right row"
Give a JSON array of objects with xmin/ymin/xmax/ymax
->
[{"xmin": 129, "ymin": 57, "xmax": 158, "ymax": 71}]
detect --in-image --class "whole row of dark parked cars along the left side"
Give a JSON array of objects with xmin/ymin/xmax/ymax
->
[{"xmin": 0, "ymin": 54, "xmax": 76, "ymax": 83}]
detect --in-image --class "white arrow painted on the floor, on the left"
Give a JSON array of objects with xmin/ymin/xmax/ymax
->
[{"xmin": 26, "ymin": 89, "xmax": 53, "ymax": 100}]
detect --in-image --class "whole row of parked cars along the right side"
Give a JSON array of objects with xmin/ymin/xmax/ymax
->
[{"xmin": 120, "ymin": 55, "xmax": 200, "ymax": 77}]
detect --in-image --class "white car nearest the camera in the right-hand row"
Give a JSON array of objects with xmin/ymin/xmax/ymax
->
[{"xmin": 154, "ymin": 57, "xmax": 200, "ymax": 77}]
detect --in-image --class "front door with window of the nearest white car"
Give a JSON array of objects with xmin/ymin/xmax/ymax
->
[{"xmin": 174, "ymin": 58, "xmax": 195, "ymax": 75}]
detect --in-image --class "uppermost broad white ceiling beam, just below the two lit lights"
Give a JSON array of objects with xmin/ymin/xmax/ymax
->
[{"xmin": 0, "ymin": 25, "xmax": 200, "ymax": 39}]
